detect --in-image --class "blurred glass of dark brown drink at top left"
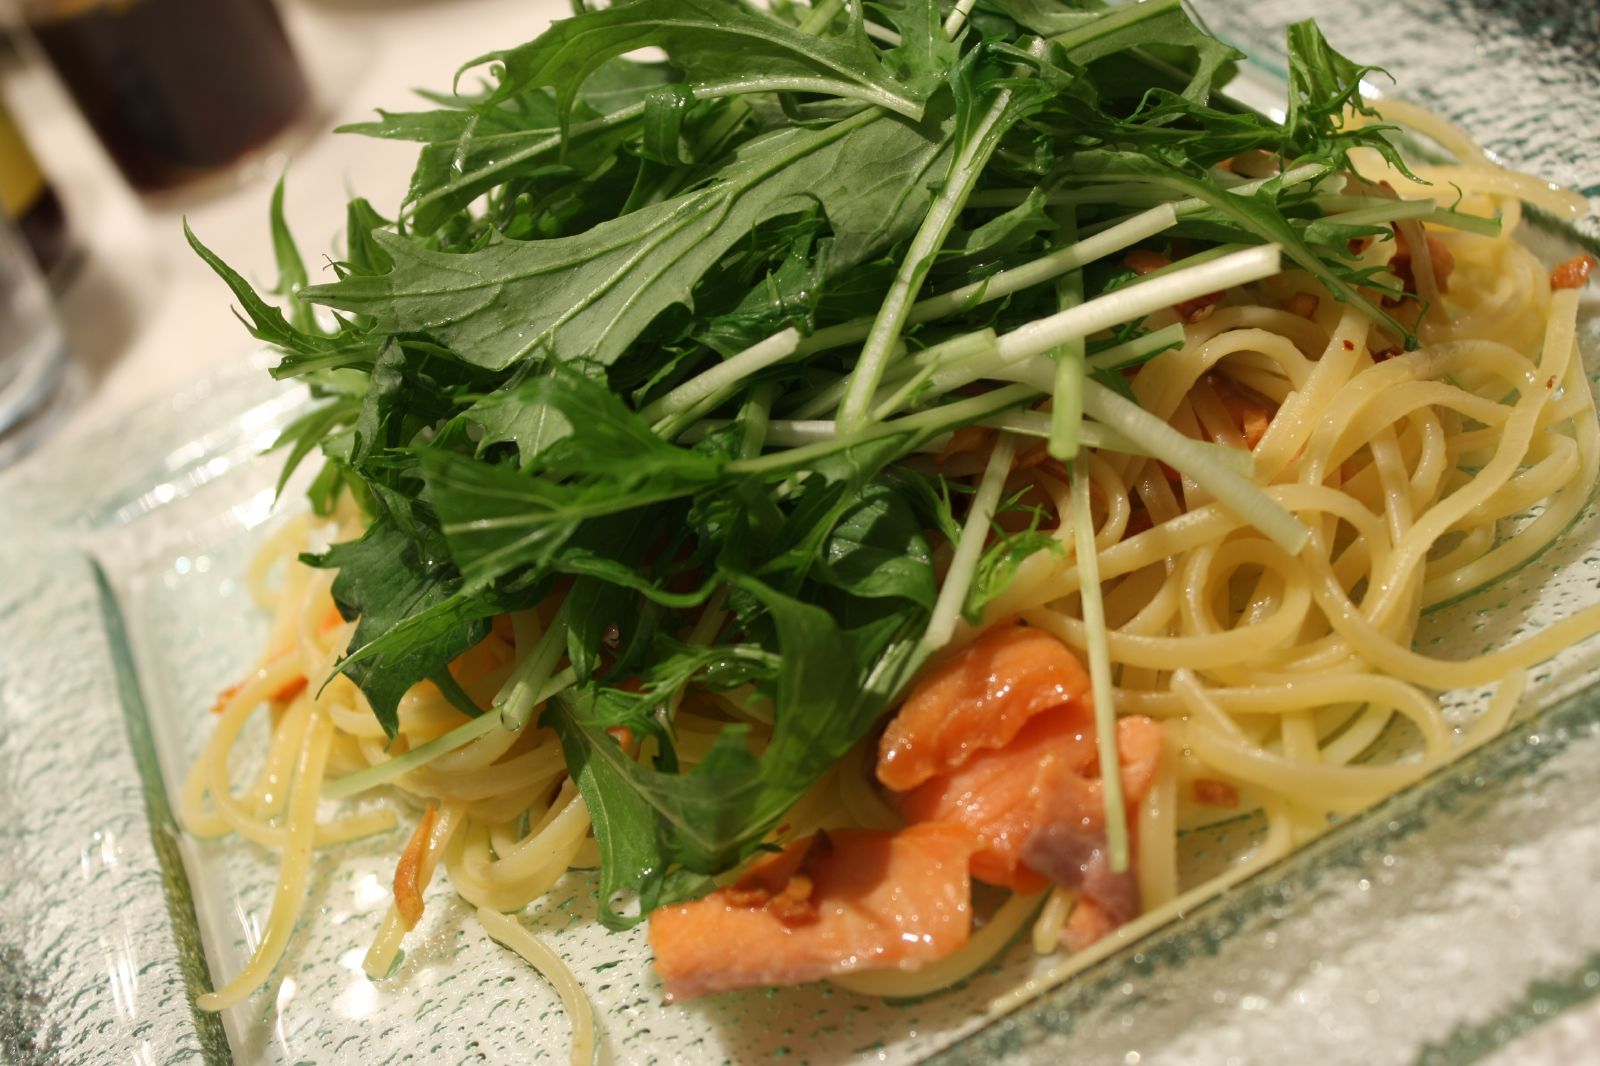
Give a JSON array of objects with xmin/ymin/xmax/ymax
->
[{"xmin": 26, "ymin": 0, "xmax": 310, "ymax": 192}]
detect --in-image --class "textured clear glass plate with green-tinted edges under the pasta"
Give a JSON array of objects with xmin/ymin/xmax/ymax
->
[{"xmin": 0, "ymin": 0, "xmax": 1600, "ymax": 1063}]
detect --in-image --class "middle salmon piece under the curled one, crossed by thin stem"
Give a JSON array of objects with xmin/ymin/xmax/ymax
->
[{"xmin": 894, "ymin": 701, "xmax": 1162, "ymax": 892}]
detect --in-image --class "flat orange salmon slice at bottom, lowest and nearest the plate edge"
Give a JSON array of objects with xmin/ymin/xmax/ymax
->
[{"xmin": 650, "ymin": 824, "xmax": 973, "ymax": 1000}]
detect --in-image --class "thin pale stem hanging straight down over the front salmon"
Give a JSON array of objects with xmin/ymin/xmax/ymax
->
[{"xmin": 1067, "ymin": 451, "xmax": 1128, "ymax": 874}]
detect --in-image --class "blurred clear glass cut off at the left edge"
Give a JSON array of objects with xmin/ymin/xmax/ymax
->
[{"xmin": 0, "ymin": 211, "xmax": 66, "ymax": 466}]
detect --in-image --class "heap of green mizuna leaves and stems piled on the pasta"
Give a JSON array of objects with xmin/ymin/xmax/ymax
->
[{"xmin": 190, "ymin": 0, "xmax": 1490, "ymax": 925}]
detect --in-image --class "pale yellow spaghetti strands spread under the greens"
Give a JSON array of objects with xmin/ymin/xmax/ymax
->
[{"xmin": 181, "ymin": 4, "xmax": 1600, "ymax": 1043}]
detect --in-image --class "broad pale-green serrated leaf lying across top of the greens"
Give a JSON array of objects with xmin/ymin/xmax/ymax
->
[{"xmin": 306, "ymin": 114, "xmax": 946, "ymax": 370}]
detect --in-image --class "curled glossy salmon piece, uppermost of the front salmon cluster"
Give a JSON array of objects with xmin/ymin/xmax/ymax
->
[{"xmin": 877, "ymin": 624, "xmax": 1093, "ymax": 792}]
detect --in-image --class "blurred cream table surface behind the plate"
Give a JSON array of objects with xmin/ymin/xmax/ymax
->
[{"xmin": 0, "ymin": 0, "xmax": 1600, "ymax": 1063}]
